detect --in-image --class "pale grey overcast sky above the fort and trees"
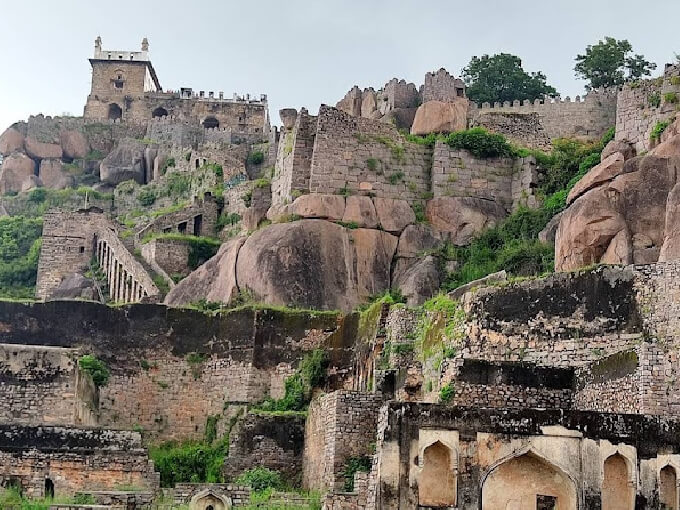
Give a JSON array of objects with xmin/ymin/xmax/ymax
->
[{"xmin": 0, "ymin": 0, "xmax": 680, "ymax": 132}]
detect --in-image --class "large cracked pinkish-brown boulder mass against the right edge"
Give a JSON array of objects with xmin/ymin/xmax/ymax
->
[{"xmin": 555, "ymin": 135, "xmax": 680, "ymax": 271}]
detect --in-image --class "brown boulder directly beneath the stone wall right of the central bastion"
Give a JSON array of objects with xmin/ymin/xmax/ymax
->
[{"xmin": 426, "ymin": 197, "xmax": 506, "ymax": 246}]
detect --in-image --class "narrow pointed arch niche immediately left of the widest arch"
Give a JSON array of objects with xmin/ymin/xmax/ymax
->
[{"xmin": 418, "ymin": 441, "xmax": 457, "ymax": 507}]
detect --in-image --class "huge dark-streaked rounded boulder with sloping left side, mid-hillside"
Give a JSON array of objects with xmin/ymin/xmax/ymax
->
[{"xmin": 165, "ymin": 220, "xmax": 398, "ymax": 311}]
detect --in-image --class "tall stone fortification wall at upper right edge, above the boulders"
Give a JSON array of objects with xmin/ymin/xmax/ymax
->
[{"xmin": 616, "ymin": 73, "xmax": 680, "ymax": 153}]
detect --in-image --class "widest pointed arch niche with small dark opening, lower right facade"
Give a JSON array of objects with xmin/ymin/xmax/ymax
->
[{"xmin": 482, "ymin": 452, "xmax": 577, "ymax": 510}]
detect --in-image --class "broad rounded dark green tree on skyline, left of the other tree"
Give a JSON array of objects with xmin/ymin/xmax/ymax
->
[{"xmin": 463, "ymin": 53, "xmax": 557, "ymax": 103}]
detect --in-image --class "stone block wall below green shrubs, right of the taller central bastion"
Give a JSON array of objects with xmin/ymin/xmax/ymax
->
[{"xmin": 432, "ymin": 141, "xmax": 538, "ymax": 211}]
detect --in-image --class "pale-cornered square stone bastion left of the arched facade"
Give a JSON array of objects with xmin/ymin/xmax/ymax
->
[{"xmin": 302, "ymin": 391, "xmax": 381, "ymax": 490}]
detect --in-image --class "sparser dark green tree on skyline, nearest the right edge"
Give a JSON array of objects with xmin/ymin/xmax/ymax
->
[{"xmin": 574, "ymin": 37, "xmax": 656, "ymax": 90}]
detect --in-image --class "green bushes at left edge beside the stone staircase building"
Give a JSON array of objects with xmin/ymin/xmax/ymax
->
[{"xmin": 0, "ymin": 216, "xmax": 42, "ymax": 298}]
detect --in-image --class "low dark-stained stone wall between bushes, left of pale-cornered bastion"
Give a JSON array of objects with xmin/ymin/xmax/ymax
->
[{"xmin": 223, "ymin": 413, "xmax": 305, "ymax": 483}]
